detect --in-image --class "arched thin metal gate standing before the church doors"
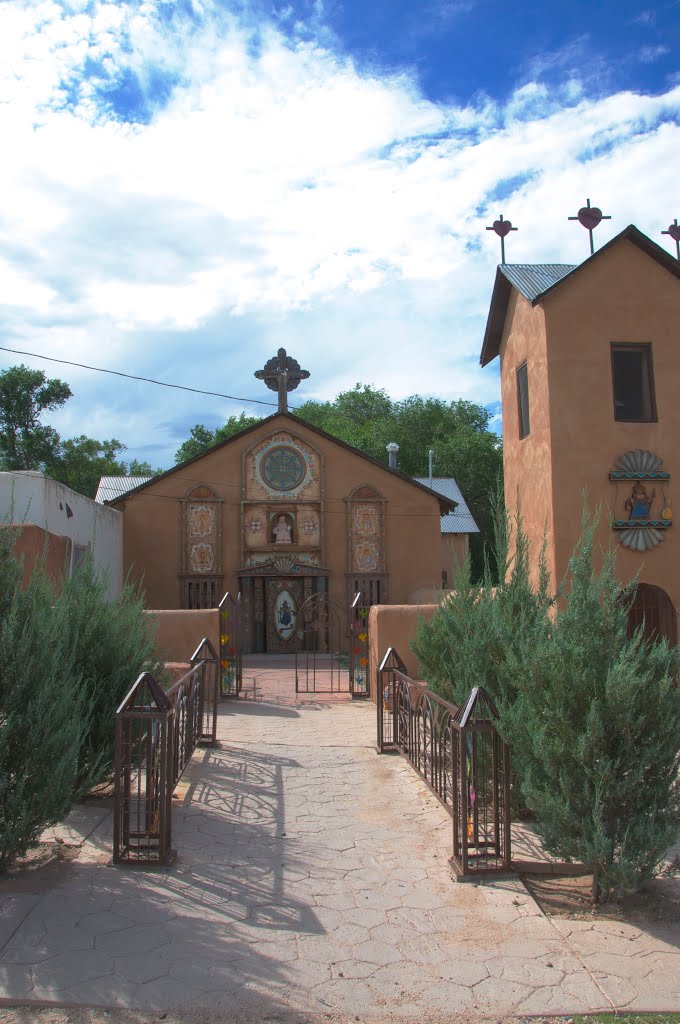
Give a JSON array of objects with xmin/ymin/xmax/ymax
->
[{"xmin": 295, "ymin": 593, "xmax": 350, "ymax": 693}]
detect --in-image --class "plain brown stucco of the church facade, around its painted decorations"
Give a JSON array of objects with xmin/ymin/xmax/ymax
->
[{"xmin": 116, "ymin": 417, "xmax": 441, "ymax": 608}]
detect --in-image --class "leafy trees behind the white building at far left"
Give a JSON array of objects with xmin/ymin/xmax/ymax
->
[{"xmin": 0, "ymin": 366, "xmax": 159, "ymax": 498}]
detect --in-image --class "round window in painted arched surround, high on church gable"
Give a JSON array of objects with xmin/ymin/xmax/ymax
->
[{"xmin": 244, "ymin": 432, "xmax": 321, "ymax": 501}]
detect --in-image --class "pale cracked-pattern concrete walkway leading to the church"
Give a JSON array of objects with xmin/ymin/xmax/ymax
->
[{"xmin": 0, "ymin": 660, "xmax": 680, "ymax": 1021}]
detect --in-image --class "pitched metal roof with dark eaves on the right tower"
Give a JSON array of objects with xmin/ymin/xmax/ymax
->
[{"xmin": 479, "ymin": 224, "xmax": 680, "ymax": 367}]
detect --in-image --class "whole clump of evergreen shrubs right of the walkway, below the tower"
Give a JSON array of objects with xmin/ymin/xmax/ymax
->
[{"xmin": 413, "ymin": 499, "xmax": 680, "ymax": 898}]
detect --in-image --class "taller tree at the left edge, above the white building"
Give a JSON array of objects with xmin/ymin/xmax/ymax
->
[{"xmin": 0, "ymin": 365, "xmax": 71, "ymax": 470}]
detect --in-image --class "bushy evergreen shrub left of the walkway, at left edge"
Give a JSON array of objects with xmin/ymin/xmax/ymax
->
[{"xmin": 0, "ymin": 528, "xmax": 156, "ymax": 869}]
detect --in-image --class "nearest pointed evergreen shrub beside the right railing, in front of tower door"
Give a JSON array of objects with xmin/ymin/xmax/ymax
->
[{"xmin": 514, "ymin": 514, "xmax": 680, "ymax": 899}]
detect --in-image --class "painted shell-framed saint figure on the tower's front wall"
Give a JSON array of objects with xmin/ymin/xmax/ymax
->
[{"xmin": 609, "ymin": 449, "xmax": 673, "ymax": 552}]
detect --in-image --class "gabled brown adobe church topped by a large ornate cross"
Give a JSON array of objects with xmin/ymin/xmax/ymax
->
[{"xmin": 109, "ymin": 349, "xmax": 456, "ymax": 653}]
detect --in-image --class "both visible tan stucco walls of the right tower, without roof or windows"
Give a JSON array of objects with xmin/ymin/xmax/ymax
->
[{"xmin": 502, "ymin": 240, "xmax": 680, "ymax": 609}]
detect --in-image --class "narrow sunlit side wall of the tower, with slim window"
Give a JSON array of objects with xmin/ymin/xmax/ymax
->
[{"xmin": 500, "ymin": 289, "xmax": 555, "ymax": 579}]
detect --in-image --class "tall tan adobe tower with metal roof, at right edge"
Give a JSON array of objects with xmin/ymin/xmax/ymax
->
[{"xmin": 480, "ymin": 223, "xmax": 680, "ymax": 643}]
